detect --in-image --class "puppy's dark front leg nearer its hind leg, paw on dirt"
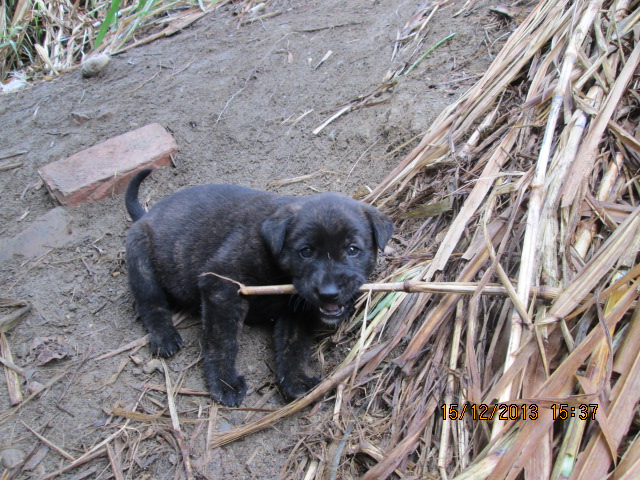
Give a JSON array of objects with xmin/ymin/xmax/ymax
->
[{"xmin": 200, "ymin": 276, "xmax": 249, "ymax": 407}]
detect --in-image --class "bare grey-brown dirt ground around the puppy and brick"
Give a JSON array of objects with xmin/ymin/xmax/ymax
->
[{"xmin": 0, "ymin": 0, "xmax": 518, "ymax": 479}]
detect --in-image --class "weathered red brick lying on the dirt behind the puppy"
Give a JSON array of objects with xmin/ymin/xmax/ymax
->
[{"xmin": 38, "ymin": 123, "xmax": 178, "ymax": 207}]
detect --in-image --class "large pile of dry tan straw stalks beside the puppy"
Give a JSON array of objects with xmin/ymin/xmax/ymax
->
[{"xmin": 215, "ymin": 0, "xmax": 640, "ymax": 479}]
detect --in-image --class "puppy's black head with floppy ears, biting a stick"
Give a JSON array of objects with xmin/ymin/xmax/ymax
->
[{"xmin": 261, "ymin": 193, "xmax": 393, "ymax": 325}]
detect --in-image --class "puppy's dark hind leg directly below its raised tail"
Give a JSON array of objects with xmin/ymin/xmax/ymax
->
[{"xmin": 126, "ymin": 231, "xmax": 182, "ymax": 357}]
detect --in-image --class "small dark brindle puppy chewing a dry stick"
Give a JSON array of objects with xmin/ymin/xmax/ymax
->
[{"xmin": 125, "ymin": 169, "xmax": 393, "ymax": 406}]
